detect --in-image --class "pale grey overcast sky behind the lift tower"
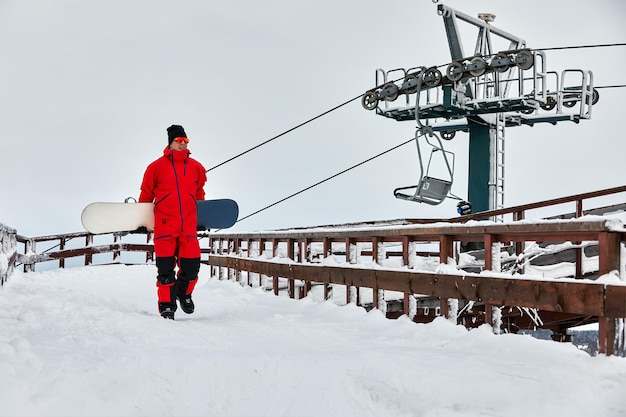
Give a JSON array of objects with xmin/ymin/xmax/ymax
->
[{"xmin": 0, "ymin": 0, "xmax": 626, "ymax": 236}]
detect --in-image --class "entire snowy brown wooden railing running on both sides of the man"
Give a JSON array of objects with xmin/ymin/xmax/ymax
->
[{"xmin": 3, "ymin": 186, "xmax": 626, "ymax": 355}]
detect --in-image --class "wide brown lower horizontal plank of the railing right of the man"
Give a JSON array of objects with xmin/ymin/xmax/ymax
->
[{"xmin": 209, "ymin": 256, "xmax": 604, "ymax": 317}]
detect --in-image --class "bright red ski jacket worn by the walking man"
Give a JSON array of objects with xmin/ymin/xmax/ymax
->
[{"xmin": 139, "ymin": 147, "xmax": 206, "ymax": 237}]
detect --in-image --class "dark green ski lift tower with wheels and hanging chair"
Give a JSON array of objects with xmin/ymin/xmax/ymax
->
[{"xmin": 361, "ymin": 0, "xmax": 599, "ymax": 220}]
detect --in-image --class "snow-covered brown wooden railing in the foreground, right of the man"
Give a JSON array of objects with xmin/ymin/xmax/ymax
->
[{"xmin": 208, "ymin": 216, "xmax": 626, "ymax": 354}]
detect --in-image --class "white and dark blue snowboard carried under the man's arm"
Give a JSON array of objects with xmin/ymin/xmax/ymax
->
[{"xmin": 81, "ymin": 198, "xmax": 239, "ymax": 234}]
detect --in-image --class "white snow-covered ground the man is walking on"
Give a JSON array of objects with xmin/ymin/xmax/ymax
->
[{"xmin": 0, "ymin": 265, "xmax": 626, "ymax": 417}]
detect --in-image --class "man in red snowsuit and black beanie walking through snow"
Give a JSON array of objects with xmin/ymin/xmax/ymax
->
[{"xmin": 139, "ymin": 125, "xmax": 206, "ymax": 320}]
